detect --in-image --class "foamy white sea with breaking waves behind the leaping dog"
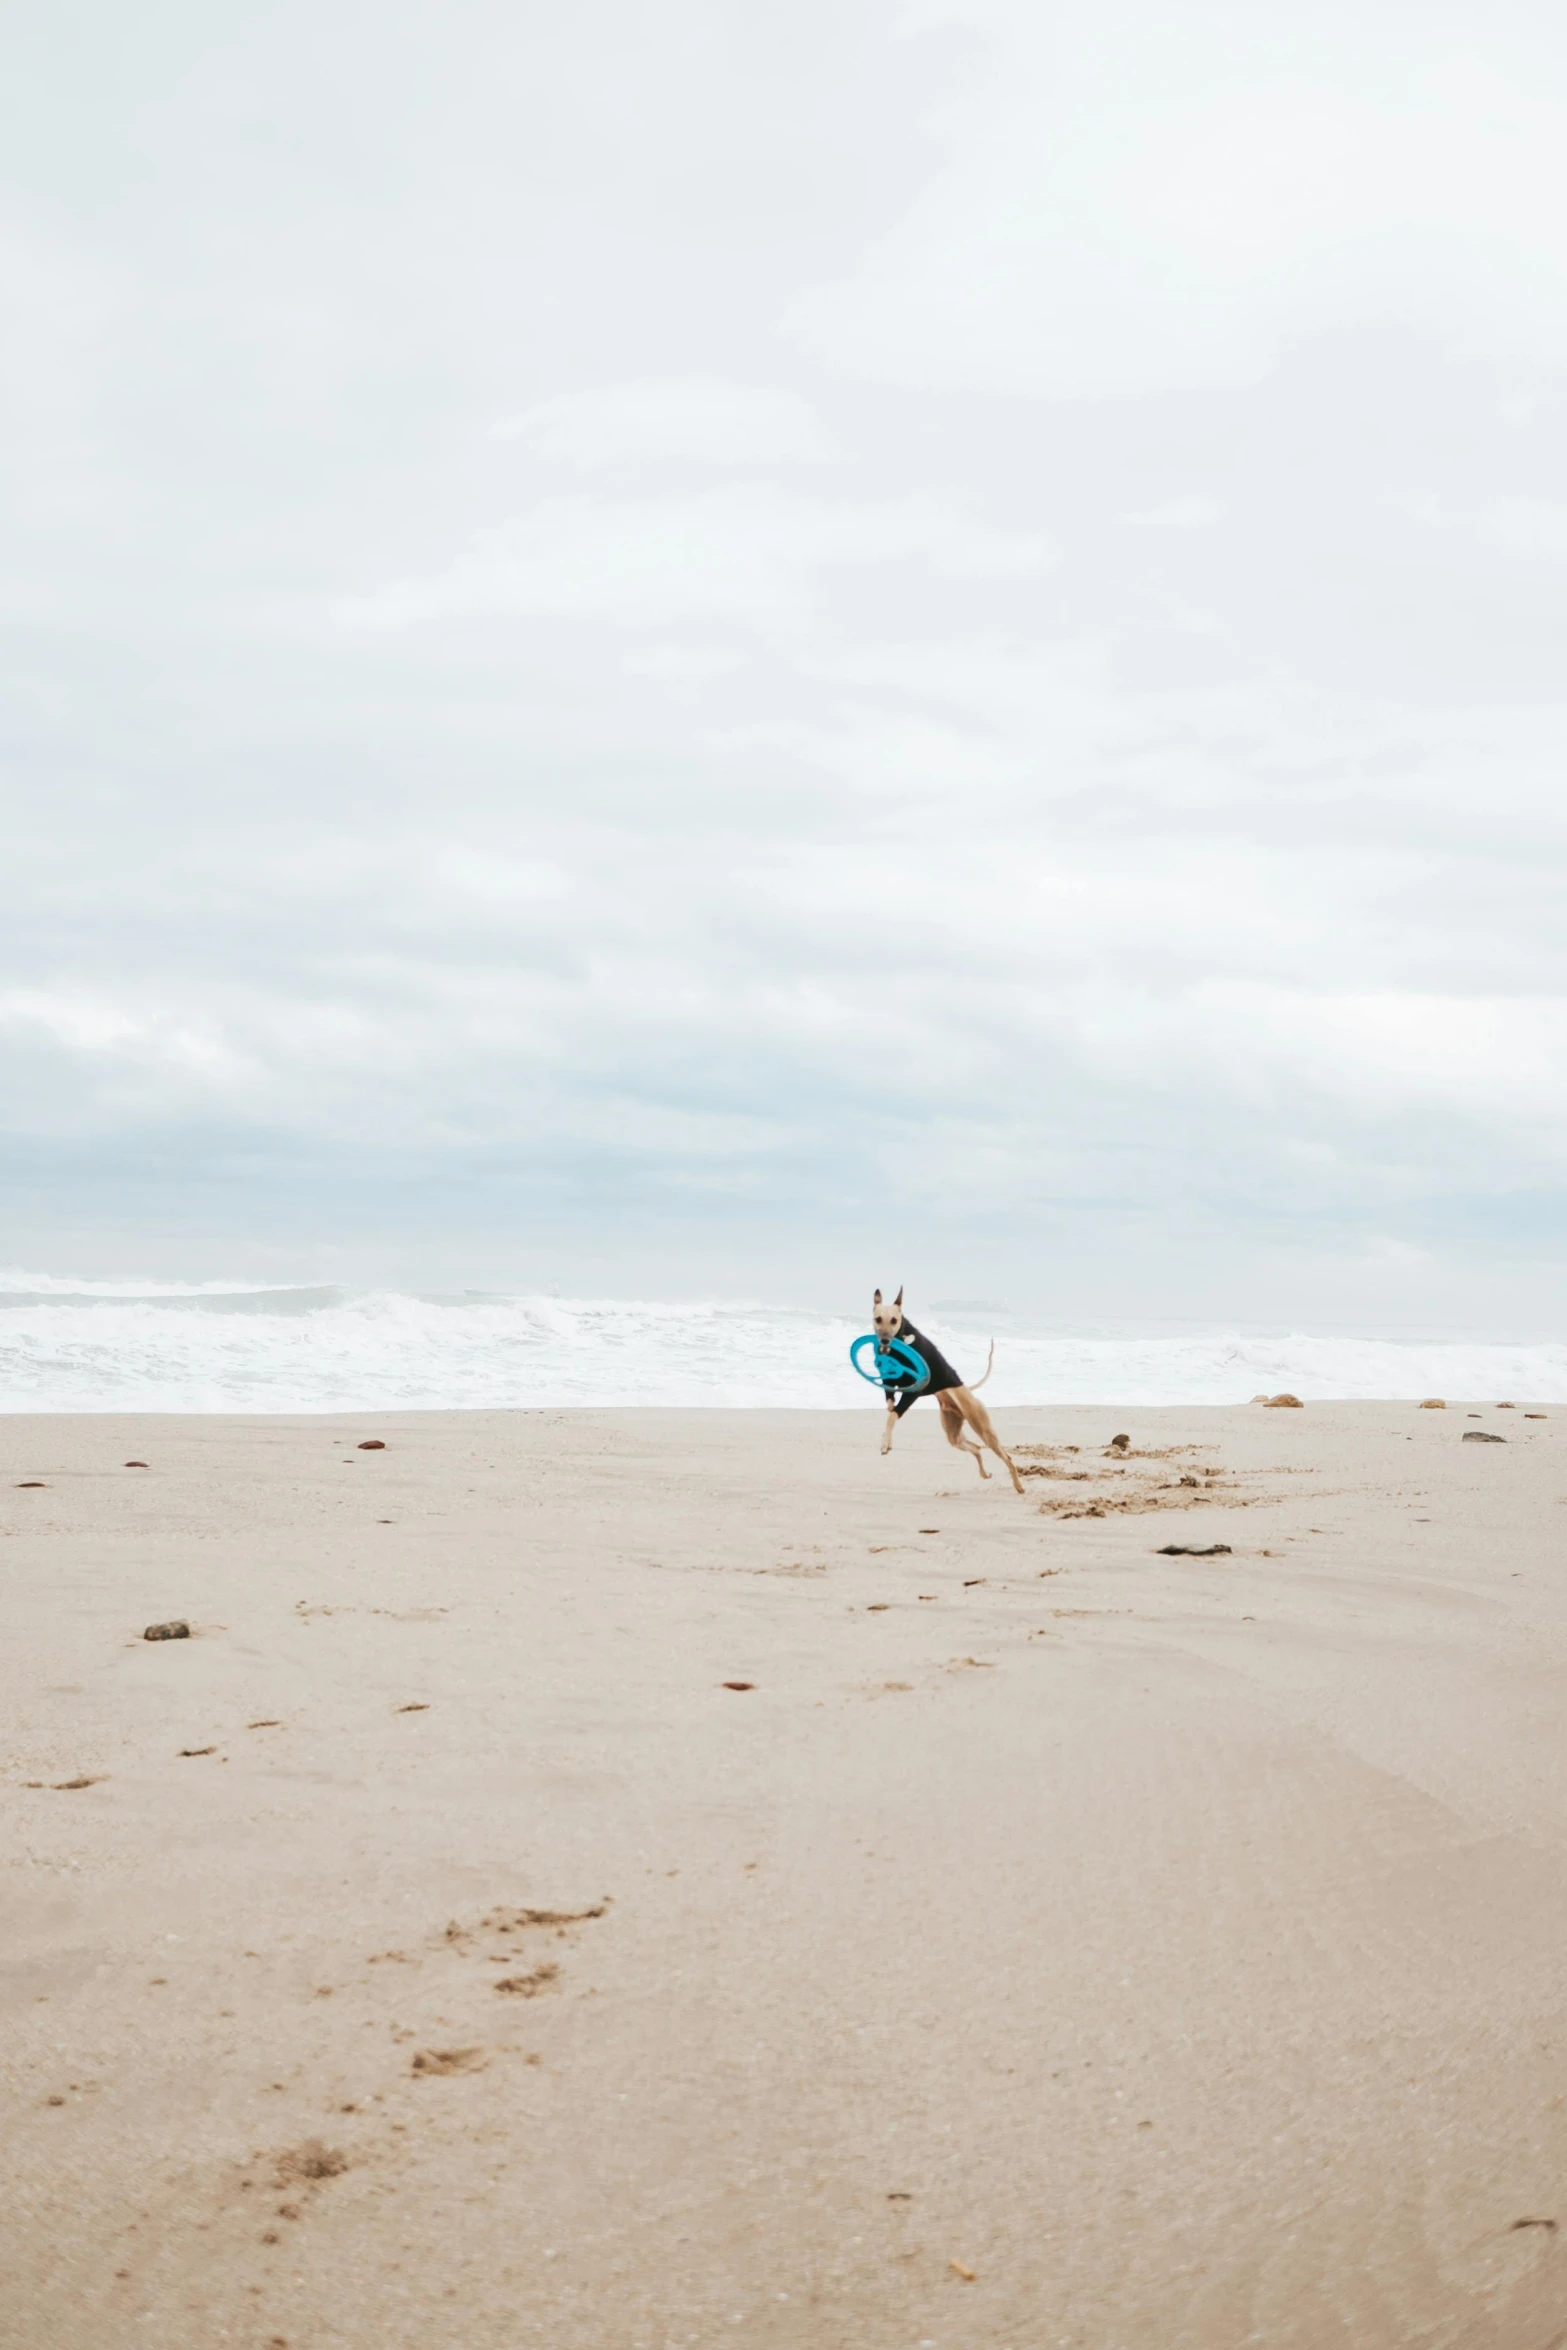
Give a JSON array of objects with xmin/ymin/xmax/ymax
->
[{"xmin": 0, "ymin": 1271, "xmax": 1567, "ymax": 1412}]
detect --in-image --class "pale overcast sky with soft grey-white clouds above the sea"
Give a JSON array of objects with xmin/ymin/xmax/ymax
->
[{"xmin": 0, "ymin": 0, "xmax": 1567, "ymax": 1335}]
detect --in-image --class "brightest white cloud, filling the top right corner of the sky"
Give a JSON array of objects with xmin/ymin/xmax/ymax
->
[{"xmin": 787, "ymin": 13, "xmax": 1567, "ymax": 400}]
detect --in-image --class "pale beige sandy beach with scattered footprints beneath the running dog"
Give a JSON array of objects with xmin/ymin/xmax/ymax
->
[{"xmin": 0, "ymin": 1405, "xmax": 1567, "ymax": 2350}]
